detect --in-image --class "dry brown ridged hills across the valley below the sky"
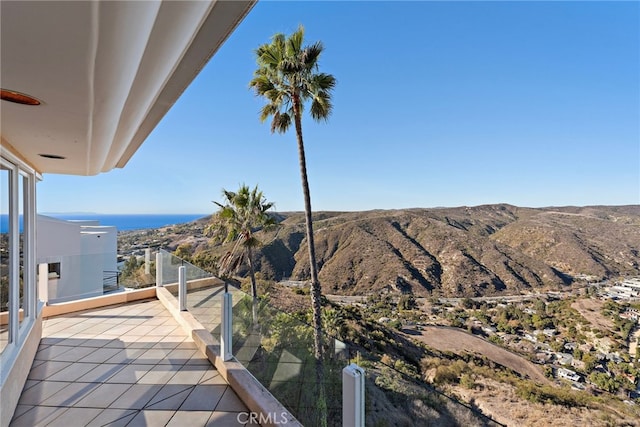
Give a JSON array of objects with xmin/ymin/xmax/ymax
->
[{"xmin": 120, "ymin": 205, "xmax": 640, "ymax": 296}]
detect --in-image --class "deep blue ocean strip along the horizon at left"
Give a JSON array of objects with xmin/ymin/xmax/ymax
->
[{"xmin": 0, "ymin": 214, "xmax": 208, "ymax": 233}]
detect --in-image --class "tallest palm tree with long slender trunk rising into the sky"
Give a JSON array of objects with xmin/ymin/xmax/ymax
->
[{"xmin": 249, "ymin": 26, "xmax": 336, "ymax": 372}]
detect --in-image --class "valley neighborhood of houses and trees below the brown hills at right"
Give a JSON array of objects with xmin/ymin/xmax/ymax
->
[{"xmin": 382, "ymin": 277, "xmax": 640, "ymax": 414}]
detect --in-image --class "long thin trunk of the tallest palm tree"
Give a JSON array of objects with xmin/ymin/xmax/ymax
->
[{"xmin": 293, "ymin": 96, "xmax": 326, "ymax": 423}]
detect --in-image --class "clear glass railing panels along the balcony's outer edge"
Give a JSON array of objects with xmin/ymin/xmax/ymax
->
[{"xmin": 163, "ymin": 254, "xmax": 499, "ymax": 426}]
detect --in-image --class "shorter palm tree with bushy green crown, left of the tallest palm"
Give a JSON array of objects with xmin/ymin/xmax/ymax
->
[{"xmin": 205, "ymin": 184, "xmax": 276, "ymax": 301}]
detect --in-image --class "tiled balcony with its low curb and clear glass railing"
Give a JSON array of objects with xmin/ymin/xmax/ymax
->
[{"xmin": 6, "ymin": 251, "xmax": 504, "ymax": 426}]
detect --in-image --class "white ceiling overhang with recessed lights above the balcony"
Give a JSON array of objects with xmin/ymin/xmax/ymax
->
[{"xmin": 0, "ymin": 0, "xmax": 255, "ymax": 175}]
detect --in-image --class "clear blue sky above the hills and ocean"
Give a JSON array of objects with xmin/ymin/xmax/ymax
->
[{"xmin": 38, "ymin": 1, "xmax": 640, "ymax": 213}]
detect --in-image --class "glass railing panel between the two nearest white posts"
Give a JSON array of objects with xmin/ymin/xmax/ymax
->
[{"xmin": 226, "ymin": 290, "xmax": 348, "ymax": 426}]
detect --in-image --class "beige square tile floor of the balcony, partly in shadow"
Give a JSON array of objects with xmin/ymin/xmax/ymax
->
[{"xmin": 10, "ymin": 300, "xmax": 248, "ymax": 427}]
